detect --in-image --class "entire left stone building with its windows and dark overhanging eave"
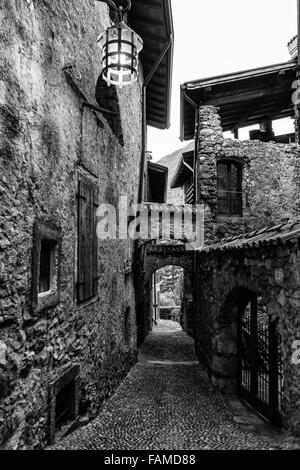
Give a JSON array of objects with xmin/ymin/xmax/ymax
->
[{"xmin": 0, "ymin": 0, "xmax": 173, "ymax": 449}]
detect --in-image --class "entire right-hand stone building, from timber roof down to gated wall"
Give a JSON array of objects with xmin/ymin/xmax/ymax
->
[{"xmin": 171, "ymin": 39, "xmax": 300, "ymax": 435}]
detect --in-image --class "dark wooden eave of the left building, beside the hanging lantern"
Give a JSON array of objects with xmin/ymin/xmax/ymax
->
[{"xmin": 129, "ymin": 0, "xmax": 174, "ymax": 129}]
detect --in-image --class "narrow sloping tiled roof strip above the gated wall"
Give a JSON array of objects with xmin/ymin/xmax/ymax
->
[{"xmin": 197, "ymin": 221, "xmax": 300, "ymax": 253}]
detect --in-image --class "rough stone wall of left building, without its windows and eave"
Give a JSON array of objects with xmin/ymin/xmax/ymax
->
[{"xmin": 0, "ymin": 0, "xmax": 141, "ymax": 449}]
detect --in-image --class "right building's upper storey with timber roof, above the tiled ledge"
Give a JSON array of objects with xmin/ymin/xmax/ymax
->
[{"xmin": 175, "ymin": 60, "xmax": 300, "ymax": 243}]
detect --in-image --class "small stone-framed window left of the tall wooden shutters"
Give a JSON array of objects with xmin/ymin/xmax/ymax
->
[{"xmin": 32, "ymin": 222, "xmax": 61, "ymax": 312}]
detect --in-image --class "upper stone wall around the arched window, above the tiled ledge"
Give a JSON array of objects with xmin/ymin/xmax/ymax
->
[{"xmin": 197, "ymin": 106, "xmax": 300, "ymax": 243}]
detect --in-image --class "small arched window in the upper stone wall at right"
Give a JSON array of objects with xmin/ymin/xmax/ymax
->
[{"xmin": 218, "ymin": 161, "xmax": 243, "ymax": 217}]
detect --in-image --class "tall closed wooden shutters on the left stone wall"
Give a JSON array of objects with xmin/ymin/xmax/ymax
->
[{"xmin": 77, "ymin": 179, "xmax": 99, "ymax": 302}]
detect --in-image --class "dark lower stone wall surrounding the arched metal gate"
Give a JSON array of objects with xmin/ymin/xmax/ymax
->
[{"xmin": 195, "ymin": 233, "xmax": 300, "ymax": 434}]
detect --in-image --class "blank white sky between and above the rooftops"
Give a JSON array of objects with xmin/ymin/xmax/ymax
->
[{"xmin": 148, "ymin": 0, "xmax": 297, "ymax": 160}]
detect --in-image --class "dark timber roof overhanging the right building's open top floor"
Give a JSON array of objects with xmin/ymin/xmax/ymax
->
[{"xmin": 180, "ymin": 61, "xmax": 296, "ymax": 140}]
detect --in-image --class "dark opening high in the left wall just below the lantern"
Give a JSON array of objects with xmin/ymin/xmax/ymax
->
[{"xmin": 95, "ymin": 75, "xmax": 124, "ymax": 146}]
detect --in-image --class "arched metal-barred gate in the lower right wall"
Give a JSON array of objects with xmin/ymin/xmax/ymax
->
[{"xmin": 238, "ymin": 296, "xmax": 283, "ymax": 426}]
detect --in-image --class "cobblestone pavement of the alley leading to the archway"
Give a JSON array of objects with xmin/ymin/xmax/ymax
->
[{"xmin": 49, "ymin": 322, "xmax": 298, "ymax": 450}]
